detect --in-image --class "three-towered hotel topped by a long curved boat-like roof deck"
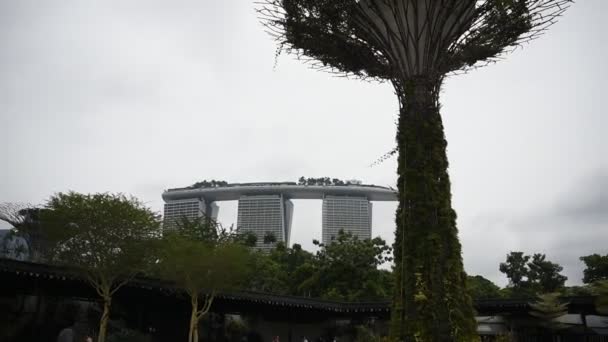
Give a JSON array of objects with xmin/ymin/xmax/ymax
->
[{"xmin": 162, "ymin": 182, "xmax": 397, "ymax": 249}]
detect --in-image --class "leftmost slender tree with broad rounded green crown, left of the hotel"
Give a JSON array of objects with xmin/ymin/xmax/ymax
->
[{"xmin": 41, "ymin": 192, "xmax": 159, "ymax": 342}]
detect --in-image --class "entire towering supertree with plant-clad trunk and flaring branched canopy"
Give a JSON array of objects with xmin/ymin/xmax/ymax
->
[{"xmin": 258, "ymin": 0, "xmax": 571, "ymax": 341}]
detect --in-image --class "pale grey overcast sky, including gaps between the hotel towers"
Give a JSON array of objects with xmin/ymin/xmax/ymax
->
[{"xmin": 0, "ymin": 0, "xmax": 608, "ymax": 285}]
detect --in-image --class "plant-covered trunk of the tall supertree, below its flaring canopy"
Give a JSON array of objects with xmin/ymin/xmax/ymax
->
[{"xmin": 391, "ymin": 80, "xmax": 476, "ymax": 342}]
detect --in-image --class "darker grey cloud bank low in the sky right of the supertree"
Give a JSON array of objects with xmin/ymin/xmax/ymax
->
[{"xmin": 461, "ymin": 169, "xmax": 608, "ymax": 284}]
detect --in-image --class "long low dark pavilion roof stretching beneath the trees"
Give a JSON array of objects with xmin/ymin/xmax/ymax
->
[{"xmin": 0, "ymin": 258, "xmax": 595, "ymax": 317}]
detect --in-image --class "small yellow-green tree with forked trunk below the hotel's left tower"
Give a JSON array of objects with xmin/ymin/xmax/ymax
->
[{"xmin": 157, "ymin": 231, "xmax": 252, "ymax": 342}]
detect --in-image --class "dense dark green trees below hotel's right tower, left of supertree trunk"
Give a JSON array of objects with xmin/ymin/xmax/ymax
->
[{"xmin": 247, "ymin": 232, "xmax": 392, "ymax": 301}]
